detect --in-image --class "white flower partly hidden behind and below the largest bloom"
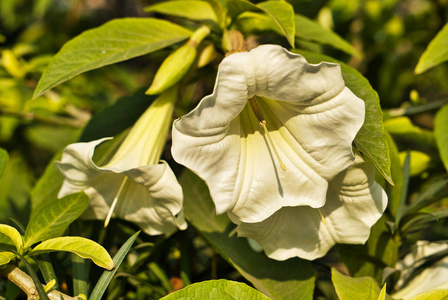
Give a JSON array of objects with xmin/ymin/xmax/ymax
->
[{"xmin": 236, "ymin": 156, "xmax": 387, "ymax": 260}]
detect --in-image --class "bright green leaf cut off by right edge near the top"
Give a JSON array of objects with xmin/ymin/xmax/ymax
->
[{"xmin": 415, "ymin": 24, "xmax": 448, "ymax": 74}]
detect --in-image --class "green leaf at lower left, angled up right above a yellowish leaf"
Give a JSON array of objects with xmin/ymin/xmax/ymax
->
[{"xmin": 25, "ymin": 193, "xmax": 89, "ymax": 248}]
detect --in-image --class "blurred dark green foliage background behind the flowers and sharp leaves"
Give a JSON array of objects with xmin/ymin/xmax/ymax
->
[{"xmin": 0, "ymin": 0, "xmax": 448, "ymax": 299}]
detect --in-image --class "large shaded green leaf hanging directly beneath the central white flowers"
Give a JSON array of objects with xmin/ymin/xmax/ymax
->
[{"xmin": 179, "ymin": 170, "xmax": 314, "ymax": 300}]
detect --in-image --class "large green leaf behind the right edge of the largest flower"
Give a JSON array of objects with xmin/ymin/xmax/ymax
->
[{"xmin": 294, "ymin": 50, "xmax": 393, "ymax": 184}]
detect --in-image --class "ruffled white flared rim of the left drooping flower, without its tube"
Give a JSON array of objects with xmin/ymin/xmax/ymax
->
[{"xmin": 56, "ymin": 139, "xmax": 186, "ymax": 235}]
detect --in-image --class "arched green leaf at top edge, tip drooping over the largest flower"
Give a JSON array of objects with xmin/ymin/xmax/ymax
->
[{"xmin": 227, "ymin": 0, "xmax": 296, "ymax": 48}]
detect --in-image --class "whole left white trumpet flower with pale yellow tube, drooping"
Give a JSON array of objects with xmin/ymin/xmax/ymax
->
[{"xmin": 56, "ymin": 90, "xmax": 187, "ymax": 235}]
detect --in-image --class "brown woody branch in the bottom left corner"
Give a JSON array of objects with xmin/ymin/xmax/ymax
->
[{"xmin": 0, "ymin": 263, "xmax": 79, "ymax": 300}]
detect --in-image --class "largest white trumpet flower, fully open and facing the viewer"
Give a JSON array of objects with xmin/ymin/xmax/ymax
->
[{"xmin": 172, "ymin": 45, "xmax": 365, "ymax": 226}]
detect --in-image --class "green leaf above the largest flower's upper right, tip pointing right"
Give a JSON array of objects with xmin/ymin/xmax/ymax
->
[{"xmin": 294, "ymin": 15, "xmax": 361, "ymax": 57}]
